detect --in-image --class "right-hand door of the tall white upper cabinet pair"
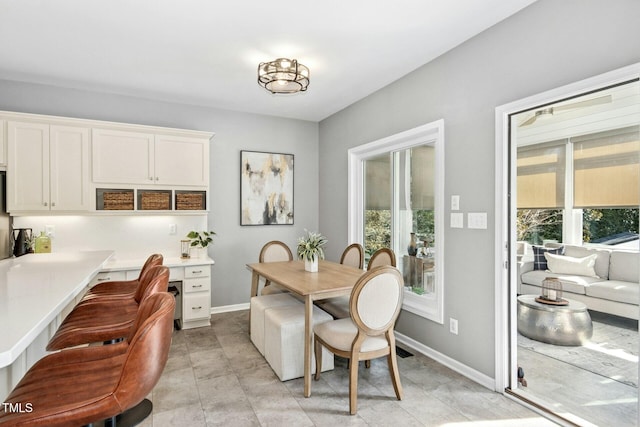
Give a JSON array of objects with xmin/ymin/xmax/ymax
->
[{"xmin": 49, "ymin": 126, "xmax": 90, "ymax": 211}]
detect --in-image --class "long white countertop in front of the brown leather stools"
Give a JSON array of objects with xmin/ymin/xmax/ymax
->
[{"xmin": 0, "ymin": 251, "xmax": 113, "ymax": 368}]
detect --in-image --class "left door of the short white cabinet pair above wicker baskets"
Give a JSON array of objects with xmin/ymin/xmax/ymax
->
[{"xmin": 91, "ymin": 129, "xmax": 156, "ymax": 184}]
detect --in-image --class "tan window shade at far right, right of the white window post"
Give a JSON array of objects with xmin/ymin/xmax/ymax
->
[{"xmin": 572, "ymin": 126, "xmax": 640, "ymax": 208}]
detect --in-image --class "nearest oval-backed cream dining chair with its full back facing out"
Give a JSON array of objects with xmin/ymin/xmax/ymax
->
[{"xmin": 313, "ymin": 266, "xmax": 404, "ymax": 415}]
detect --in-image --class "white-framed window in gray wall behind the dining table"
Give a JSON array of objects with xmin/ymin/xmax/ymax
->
[{"xmin": 349, "ymin": 120, "xmax": 444, "ymax": 323}]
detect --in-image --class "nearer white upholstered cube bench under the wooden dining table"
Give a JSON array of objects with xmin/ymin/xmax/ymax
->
[{"xmin": 264, "ymin": 304, "xmax": 333, "ymax": 381}]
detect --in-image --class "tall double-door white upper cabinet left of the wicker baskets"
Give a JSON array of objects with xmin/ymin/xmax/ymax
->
[{"xmin": 7, "ymin": 121, "xmax": 89, "ymax": 212}]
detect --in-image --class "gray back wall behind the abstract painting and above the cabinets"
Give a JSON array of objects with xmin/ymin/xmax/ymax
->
[{"xmin": 0, "ymin": 80, "xmax": 318, "ymax": 307}]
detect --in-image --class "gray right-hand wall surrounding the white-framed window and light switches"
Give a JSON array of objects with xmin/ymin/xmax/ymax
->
[{"xmin": 320, "ymin": 0, "xmax": 640, "ymax": 377}]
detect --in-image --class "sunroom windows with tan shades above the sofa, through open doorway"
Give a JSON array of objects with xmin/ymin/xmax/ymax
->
[{"xmin": 513, "ymin": 81, "xmax": 640, "ymax": 249}]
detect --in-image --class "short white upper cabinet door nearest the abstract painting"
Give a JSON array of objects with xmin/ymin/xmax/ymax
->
[{"xmin": 154, "ymin": 135, "xmax": 209, "ymax": 187}]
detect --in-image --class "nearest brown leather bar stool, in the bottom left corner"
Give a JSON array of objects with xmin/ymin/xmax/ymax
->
[{"xmin": 0, "ymin": 292, "xmax": 175, "ymax": 427}]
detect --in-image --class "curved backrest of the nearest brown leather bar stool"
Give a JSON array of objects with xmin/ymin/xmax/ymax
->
[{"xmin": 114, "ymin": 294, "xmax": 176, "ymax": 412}]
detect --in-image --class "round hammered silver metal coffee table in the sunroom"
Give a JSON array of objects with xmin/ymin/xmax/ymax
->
[{"xmin": 518, "ymin": 295, "xmax": 593, "ymax": 345}]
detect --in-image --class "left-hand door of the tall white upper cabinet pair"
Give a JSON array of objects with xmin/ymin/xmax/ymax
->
[{"xmin": 7, "ymin": 121, "xmax": 49, "ymax": 212}]
